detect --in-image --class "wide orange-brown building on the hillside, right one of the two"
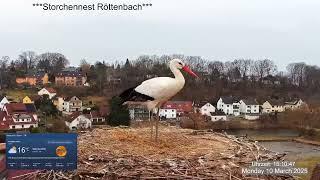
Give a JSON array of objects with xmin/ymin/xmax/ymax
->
[{"xmin": 55, "ymin": 71, "xmax": 87, "ymax": 86}]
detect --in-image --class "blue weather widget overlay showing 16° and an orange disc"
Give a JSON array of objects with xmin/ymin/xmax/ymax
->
[{"xmin": 6, "ymin": 133, "xmax": 77, "ymax": 170}]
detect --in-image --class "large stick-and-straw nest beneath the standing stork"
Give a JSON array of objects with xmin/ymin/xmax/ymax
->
[{"xmin": 29, "ymin": 126, "xmax": 292, "ymax": 179}]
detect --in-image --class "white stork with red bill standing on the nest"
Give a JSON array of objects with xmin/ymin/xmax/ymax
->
[{"xmin": 119, "ymin": 59, "xmax": 198, "ymax": 141}]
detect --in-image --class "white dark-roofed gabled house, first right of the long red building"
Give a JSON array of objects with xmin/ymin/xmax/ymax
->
[{"xmin": 217, "ymin": 96, "xmax": 240, "ymax": 116}]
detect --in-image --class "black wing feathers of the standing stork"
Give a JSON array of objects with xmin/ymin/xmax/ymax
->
[{"xmin": 119, "ymin": 87, "xmax": 154, "ymax": 103}]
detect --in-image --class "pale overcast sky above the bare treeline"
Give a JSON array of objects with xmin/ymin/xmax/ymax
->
[{"xmin": 0, "ymin": 0, "xmax": 320, "ymax": 69}]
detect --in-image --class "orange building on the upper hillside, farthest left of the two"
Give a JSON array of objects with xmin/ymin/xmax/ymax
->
[{"xmin": 16, "ymin": 72, "xmax": 49, "ymax": 86}]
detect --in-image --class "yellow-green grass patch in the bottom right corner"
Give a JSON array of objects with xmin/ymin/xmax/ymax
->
[{"xmin": 295, "ymin": 157, "xmax": 320, "ymax": 180}]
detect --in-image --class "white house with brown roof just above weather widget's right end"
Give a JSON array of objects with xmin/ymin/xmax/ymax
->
[{"xmin": 65, "ymin": 112, "xmax": 92, "ymax": 130}]
